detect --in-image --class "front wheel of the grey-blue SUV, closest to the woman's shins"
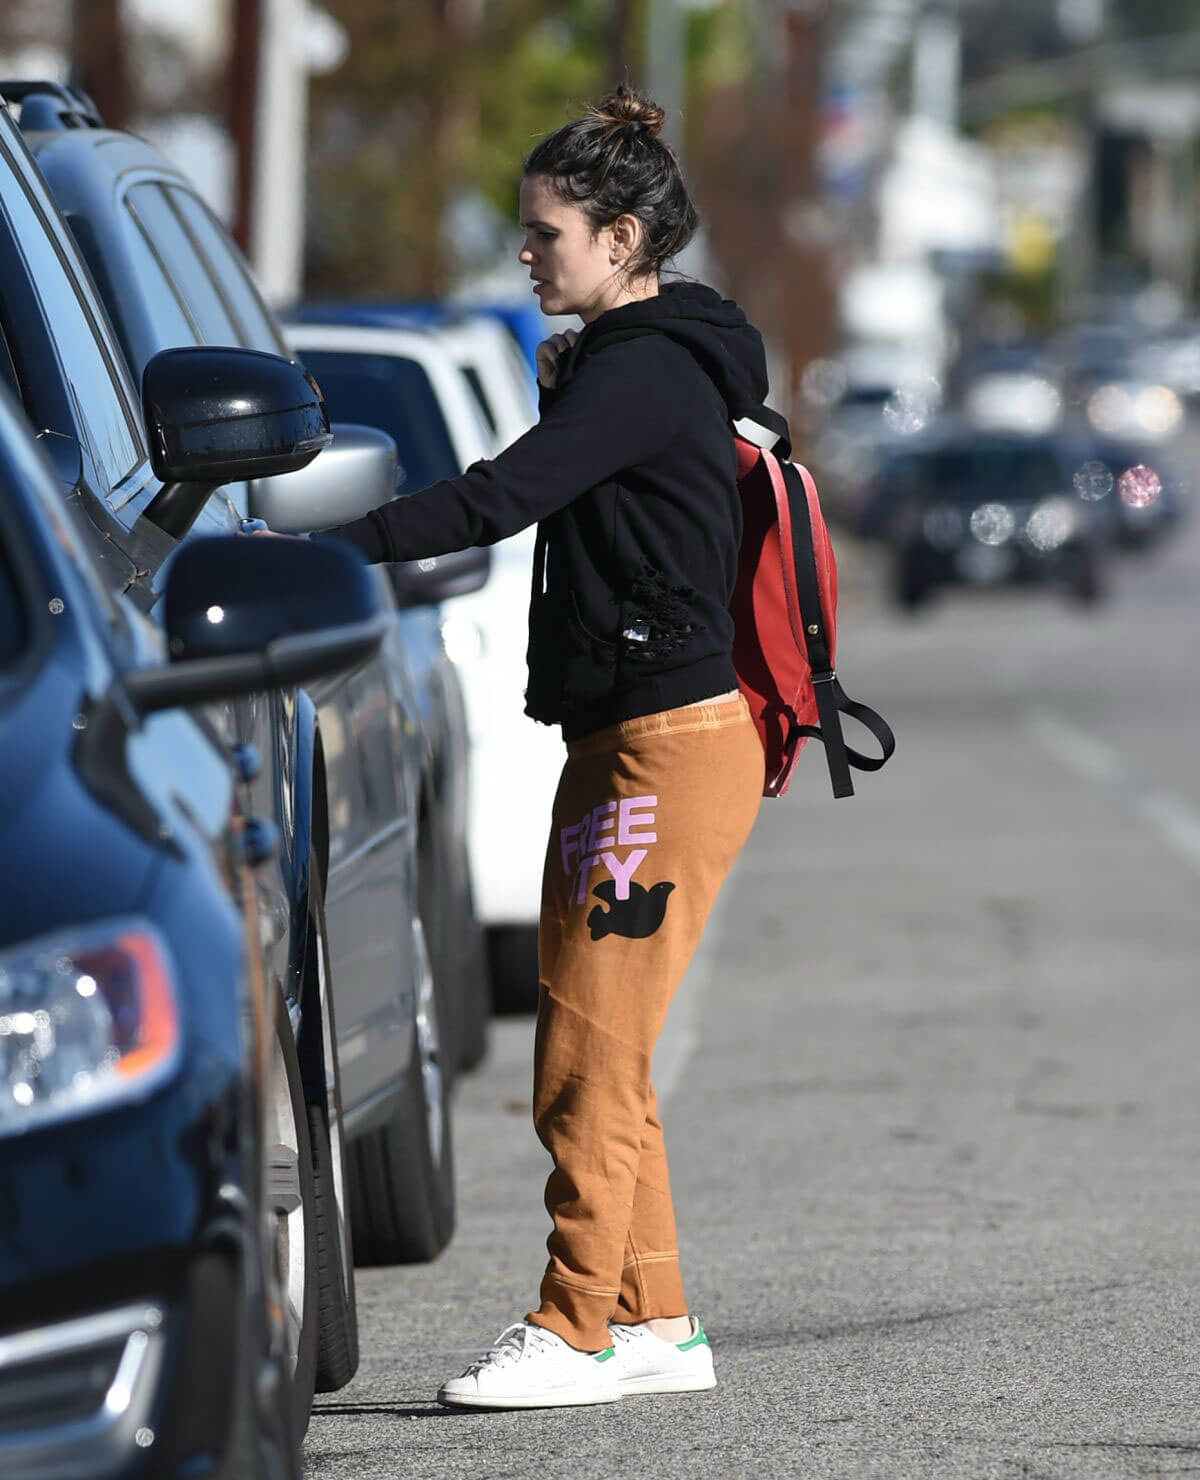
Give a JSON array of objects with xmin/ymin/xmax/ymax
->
[{"xmin": 349, "ymin": 919, "xmax": 454, "ymax": 1264}]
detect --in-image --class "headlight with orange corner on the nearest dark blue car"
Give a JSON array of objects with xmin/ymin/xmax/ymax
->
[{"xmin": 0, "ymin": 919, "xmax": 181, "ymax": 1135}]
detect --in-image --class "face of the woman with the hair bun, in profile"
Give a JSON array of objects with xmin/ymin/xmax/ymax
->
[{"xmin": 521, "ymin": 175, "xmax": 629, "ymax": 323}]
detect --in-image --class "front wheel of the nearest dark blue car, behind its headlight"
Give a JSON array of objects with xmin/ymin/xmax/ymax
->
[{"xmin": 265, "ymin": 993, "xmax": 317, "ymax": 1439}]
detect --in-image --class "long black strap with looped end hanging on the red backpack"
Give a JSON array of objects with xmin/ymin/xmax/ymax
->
[{"xmin": 781, "ymin": 462, "xmax": 895, "ymax": 796}]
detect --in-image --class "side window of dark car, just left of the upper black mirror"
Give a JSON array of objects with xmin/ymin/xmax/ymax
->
[{"xmin": 0, "ymin": 139, "xmax": 145, "ymax": 487}]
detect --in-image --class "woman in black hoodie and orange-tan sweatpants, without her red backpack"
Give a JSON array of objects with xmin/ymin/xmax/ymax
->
[{"xmin": 315, "ymin": 86, "xmax": 766, "ymax": 1407}]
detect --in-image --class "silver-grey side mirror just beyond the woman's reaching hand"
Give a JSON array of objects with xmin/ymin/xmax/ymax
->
[{"xmin": 249, "ymin": 422, "xmax": 398, "ymax": 534}]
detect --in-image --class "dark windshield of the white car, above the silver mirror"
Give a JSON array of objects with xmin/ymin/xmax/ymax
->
[{"xmin": 300, "ymin": 349, "xmax": 462, "ymax": 493}]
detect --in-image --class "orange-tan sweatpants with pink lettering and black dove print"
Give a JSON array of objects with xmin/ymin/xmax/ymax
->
[{"xmin": 527, "ymin": 696, "xmax": 764, "ymax": 1351}]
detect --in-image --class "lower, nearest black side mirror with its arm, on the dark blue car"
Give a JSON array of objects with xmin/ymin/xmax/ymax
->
[{"xmin": 124, "ymin": 534, "xmax": 391, "ymax": 715}]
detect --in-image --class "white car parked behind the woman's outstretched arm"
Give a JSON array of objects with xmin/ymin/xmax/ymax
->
[{"xmin": 289, "ymin": 319, "xmax": 564, "ymax": 1009}]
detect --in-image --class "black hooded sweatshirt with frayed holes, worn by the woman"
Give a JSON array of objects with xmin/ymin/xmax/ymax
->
[{"xmin": 316, "ymin": 283, "xmax": 766, "ymax": 740}]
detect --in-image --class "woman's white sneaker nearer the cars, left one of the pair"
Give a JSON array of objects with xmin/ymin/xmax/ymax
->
[{"xmin": 438, "ymin": 1320, "xmax": 621, "ymax": 1407}]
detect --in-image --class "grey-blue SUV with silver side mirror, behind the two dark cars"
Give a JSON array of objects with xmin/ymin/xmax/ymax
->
[{"xmin": 8, "ymin": 81, "xmax": 490, "ymax": 1284}]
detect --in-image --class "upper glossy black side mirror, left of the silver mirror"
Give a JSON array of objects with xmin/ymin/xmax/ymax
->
[{"xmin": 142, "ymin": 345, "xmax": 330, "ymax": 539}]
